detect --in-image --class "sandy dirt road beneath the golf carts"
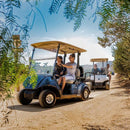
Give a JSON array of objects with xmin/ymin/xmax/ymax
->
[{"xmin": 0, "ymin": 76, "xmax": 130, "ymax": 130}]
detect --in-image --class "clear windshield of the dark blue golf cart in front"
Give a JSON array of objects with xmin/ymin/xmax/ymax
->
[{"xmin": 31, "ymin": 48, "xmax": 56, "ymax": 75}]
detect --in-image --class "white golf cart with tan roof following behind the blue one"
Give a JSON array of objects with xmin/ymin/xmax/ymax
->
[{"xmin": 86, "ymin": 58, "xmax": 110, "ymax": 90}]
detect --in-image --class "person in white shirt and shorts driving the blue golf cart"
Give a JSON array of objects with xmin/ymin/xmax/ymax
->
[{"xmin": 58, "ymin": 54, "xmax": 77, "ymax": 93}]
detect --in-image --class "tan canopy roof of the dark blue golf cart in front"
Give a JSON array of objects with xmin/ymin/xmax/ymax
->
[{"xmin": 31, "ymin": 41, "xmax": 86, "ymax": 54}]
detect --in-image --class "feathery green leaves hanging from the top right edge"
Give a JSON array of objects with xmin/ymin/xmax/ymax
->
[{"xmin": 49, "ymin": 0, "xmax": 130, "ymax": 31}]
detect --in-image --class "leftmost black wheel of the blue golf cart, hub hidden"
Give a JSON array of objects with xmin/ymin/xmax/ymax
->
[{"xmin": 17, "ymin": 89, "xmax": 32, "ymax": 105}]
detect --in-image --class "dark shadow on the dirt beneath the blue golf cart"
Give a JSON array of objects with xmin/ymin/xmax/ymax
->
[{"xmin": 8, "ymin": 97, "xmax": 93, "ymax": 112}]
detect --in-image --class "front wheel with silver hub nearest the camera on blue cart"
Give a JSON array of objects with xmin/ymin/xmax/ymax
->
[{"xmin": 39, "ymin": 90, "xmax": 56, "ymax": 107}]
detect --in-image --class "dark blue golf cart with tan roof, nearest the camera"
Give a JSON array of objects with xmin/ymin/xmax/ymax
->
[{"xmin": 17, "ymin": 41, "xmax": 91, "ymax": 107}]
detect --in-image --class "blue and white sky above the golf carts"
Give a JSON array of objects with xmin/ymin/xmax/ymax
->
[{"xmin": 2, "ymin": 0, "xmax": 113, "ymax": 65}]
